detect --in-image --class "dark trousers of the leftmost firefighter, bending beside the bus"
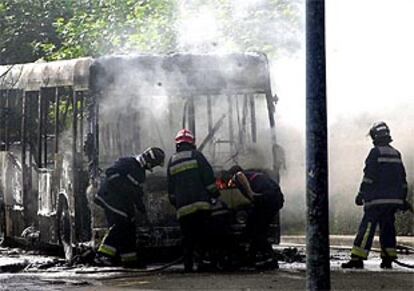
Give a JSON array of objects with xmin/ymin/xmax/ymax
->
[{"xmin": 98, "ymin": 208, "xmax": 137, "ymax": 265}]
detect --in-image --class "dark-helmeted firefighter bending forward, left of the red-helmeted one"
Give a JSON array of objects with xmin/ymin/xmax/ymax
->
[{"xmin": 95, "ymin": 147, "xmax": 165, "ymax": 267}]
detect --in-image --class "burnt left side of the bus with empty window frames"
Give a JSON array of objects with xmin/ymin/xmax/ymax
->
[{"xmin": 0, "ymin": 59, "xmax": 92, "ymax": 258}]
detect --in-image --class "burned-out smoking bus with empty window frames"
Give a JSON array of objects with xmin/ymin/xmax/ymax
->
[{"xmin": 0, "ymin": 53, "xmax": 280, "ymax": 257}]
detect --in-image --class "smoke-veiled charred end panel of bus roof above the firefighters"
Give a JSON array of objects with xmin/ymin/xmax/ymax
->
[{"xmin": 93, "ymin": 53, "xmax": 270, "ymax": 95}]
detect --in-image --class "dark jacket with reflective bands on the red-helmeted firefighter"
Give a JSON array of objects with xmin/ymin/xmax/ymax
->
[{"xmin": 167, "ymin": 149, "xmax": 219, "ymax": 218}]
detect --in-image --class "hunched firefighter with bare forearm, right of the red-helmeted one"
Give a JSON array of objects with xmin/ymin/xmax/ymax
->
[{"xmin": 229, "ymin": 165, "xmax": 284, "ymax": 269}]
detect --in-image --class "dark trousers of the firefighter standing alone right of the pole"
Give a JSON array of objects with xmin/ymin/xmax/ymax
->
[{"xmin": 351, "ymin": 204, "xmax": 397, "ymax": 259}]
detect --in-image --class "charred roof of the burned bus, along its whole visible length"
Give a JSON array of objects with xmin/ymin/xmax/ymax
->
[{"xmin": 0, "ymin": 53, "xmax": 270, "ymax": 95}]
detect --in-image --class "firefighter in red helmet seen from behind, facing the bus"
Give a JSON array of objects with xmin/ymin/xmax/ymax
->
[{"xmin": 167, "ymin": 129, "xmax": 219, "ymax": 272}]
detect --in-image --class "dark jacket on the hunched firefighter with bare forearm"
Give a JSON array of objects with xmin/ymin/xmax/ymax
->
[{"xmin": 239, "ymin": 171, "xmax": 285, "ymax": 211}]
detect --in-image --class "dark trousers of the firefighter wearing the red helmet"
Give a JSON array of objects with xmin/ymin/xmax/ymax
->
[{"xmin": 179, "ymin": 211, "xmax": 210, "ymax": 271}]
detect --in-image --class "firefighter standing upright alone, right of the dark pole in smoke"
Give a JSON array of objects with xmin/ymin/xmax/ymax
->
[{"xmin": 342, "ymin": 122, "xmax": 408, "ymax": 269}]
